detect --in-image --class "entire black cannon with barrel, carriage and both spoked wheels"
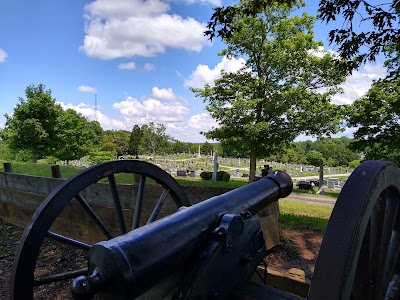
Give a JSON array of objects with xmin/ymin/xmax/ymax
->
[{"xmin": 7, "ymin": 161, "xmax": 400, "ymax": 300}]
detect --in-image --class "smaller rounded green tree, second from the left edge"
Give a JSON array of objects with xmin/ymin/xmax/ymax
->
[{"xmin": 54, "ymin": 109, "xmax": 98, "ymax": 165}]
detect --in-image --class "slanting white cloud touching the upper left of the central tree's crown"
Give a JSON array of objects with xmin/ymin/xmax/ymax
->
[{"xmin": 184, "ymin": 56, "xmax": 245, "ymax": 88}]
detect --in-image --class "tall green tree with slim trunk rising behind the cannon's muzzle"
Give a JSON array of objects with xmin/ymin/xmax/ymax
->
[{"xmin": 193, "ymin": 1, "xmax": 344, "ymax": 181}]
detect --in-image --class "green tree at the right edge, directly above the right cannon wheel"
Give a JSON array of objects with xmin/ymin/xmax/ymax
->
[{"xmin": 348, "ymin": 78, "xmax": 400, "ymax": 163}]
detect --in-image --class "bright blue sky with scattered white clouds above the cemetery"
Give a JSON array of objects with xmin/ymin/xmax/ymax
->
[{"xmin": 0, "ymin": 0, "xmax": 386, "ymax": 142}]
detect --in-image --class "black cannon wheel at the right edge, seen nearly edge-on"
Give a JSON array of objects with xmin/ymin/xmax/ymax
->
[{"xmin": 308, "ymin": 161, "xmax": 400, "ymax": 300}]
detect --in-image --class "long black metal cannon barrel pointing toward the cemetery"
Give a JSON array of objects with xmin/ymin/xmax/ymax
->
[{"xmin": 73, "ymin": 171, "xmax": 293, "ymax": 300}]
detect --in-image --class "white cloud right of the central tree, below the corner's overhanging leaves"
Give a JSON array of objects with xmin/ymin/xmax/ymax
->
[{"xmin": 332, "ymin": 64, "xmax": 386, "ymax": 104}]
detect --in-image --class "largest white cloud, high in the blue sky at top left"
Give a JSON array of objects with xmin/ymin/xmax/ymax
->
[{"xmin": 81, "ymin": 0, "xmax": 208, "ymax": 59}]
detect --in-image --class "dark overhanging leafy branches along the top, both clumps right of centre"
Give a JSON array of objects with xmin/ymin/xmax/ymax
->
[{"xmin": 205, "ymin": 0, "xmax": 400, "ymax": 78}]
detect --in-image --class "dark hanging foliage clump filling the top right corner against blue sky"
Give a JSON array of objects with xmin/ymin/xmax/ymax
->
[{"xmin": 319, "ymin": 0, "xmax": 400, "ymax": 78}]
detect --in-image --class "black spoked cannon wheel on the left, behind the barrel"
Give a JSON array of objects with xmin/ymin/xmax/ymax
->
[{"xmin": 11, "ymin": 160, "xmax": 190, "ymax": 300}]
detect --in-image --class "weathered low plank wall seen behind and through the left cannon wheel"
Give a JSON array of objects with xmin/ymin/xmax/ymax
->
[{"xmin": 0, "ymin": 172, "xmax": 279, "ymax": 249}]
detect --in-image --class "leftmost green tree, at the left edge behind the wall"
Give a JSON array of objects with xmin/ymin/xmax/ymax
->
[{"xmin": 1, "ymin": 84, "xmax": 62, "ymax": 162}]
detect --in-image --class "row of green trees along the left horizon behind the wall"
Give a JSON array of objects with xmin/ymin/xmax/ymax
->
[{"xmin": 0, "ymin": 84, "xmax": 219, "ymax": 163}]
